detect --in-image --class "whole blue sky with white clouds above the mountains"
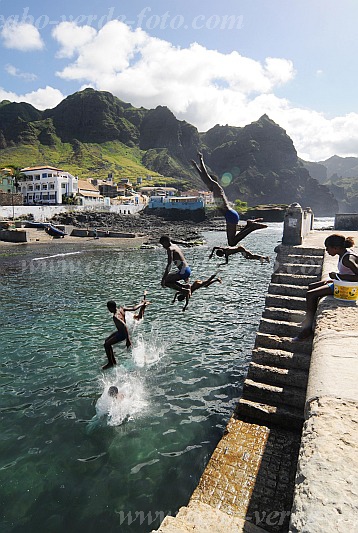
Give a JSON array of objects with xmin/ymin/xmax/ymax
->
[{"xmin": 0, "ymin": 0, "xmax": 358, "ymax": 161}]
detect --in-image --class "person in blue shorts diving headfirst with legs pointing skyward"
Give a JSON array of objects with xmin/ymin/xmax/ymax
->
[{"xmin": 191, "ymin": 152, "xmax": 267, "ymax": 246}]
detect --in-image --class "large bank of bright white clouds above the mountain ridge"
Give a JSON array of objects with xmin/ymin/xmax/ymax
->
[{"xmin": 0, "ymin": 20, "xmax": 358, "ymax": 160}]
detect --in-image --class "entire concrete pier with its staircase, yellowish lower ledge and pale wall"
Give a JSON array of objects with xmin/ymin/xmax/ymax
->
[{"xmin": 153, "ymin": 225, "xmax": 358, "ymax": 533}]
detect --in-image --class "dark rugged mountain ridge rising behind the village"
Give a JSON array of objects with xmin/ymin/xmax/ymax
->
[{"xmin": 0, "ymin": 89, "xmax": 337, "ymax": 215}]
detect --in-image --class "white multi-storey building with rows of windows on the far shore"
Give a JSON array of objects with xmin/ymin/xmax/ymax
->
[{"xmin": 19, "ymin": 166, "xmax": 78, "ymax": 205}]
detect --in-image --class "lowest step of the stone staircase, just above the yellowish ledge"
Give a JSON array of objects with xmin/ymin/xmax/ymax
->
[{"xmin": 236, "ymin": 398, "xmax": 303, "ymax": 431}]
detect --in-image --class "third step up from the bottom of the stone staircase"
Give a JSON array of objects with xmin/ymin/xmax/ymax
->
[{"xmin": 252, "ymin": 348, "xmax": 311, "ymax": 371}]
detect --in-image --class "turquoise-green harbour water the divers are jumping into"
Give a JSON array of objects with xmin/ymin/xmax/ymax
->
[{"xmin": 0, "ymin": 224, "xmax": 282, "ymax": 533}]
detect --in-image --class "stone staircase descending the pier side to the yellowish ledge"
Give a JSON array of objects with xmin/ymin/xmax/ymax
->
[{"xmin": 236, "ymin": 245, "xmax": 324, "ymax": 430}]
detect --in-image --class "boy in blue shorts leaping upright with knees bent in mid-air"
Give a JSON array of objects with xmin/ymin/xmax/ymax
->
[{"xmin": 159, "ymin": 235, "xmax": 191, "ymax": 301}]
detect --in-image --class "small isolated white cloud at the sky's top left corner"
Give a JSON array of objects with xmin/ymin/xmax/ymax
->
[{"xmin": 0, "ymin": 21, "xmax": 44, "ymax": 52}]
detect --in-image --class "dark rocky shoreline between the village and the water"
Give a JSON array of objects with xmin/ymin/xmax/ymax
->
[{"xmin": 51, "ymin": 212, "xmax": 225, "ymax": 244}]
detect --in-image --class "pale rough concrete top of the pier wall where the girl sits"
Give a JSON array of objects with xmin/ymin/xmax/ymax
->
[{"xmin": 289, "ymin": 250, "xmax": 358, "ymax": 533}]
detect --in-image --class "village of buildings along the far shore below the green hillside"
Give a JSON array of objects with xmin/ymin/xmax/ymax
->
[{"xmin": 0, "ymin": 165, "xmax": 213, "ymax": 242}]
